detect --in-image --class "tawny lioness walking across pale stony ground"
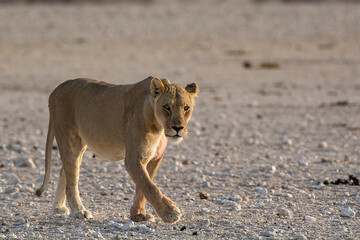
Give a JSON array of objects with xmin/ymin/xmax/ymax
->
[{"xmin": 36, "ymin": 77, "xmax": 199, "ymax": 223}]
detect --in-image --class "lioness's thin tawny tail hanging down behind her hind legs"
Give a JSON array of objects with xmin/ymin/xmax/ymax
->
[{"xmin": 36, "ymin": 115, "xmax": 54, "ymax": 197}]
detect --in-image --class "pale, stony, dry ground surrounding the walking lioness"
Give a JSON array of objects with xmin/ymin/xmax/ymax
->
[{"xmin": 0, "ymin": 0, "xmax": 360, "ymax": 239}]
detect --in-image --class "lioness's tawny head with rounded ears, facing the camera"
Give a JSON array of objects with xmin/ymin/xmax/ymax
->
[{"xmin": 150, "ymin": 78, "xmax": 199, "ymax": 142}]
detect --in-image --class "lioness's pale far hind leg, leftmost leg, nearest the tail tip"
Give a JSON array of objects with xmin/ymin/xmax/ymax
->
[{"xmin": 53, "ymin": 168, "xmax": 70, "ymax": 214}]
